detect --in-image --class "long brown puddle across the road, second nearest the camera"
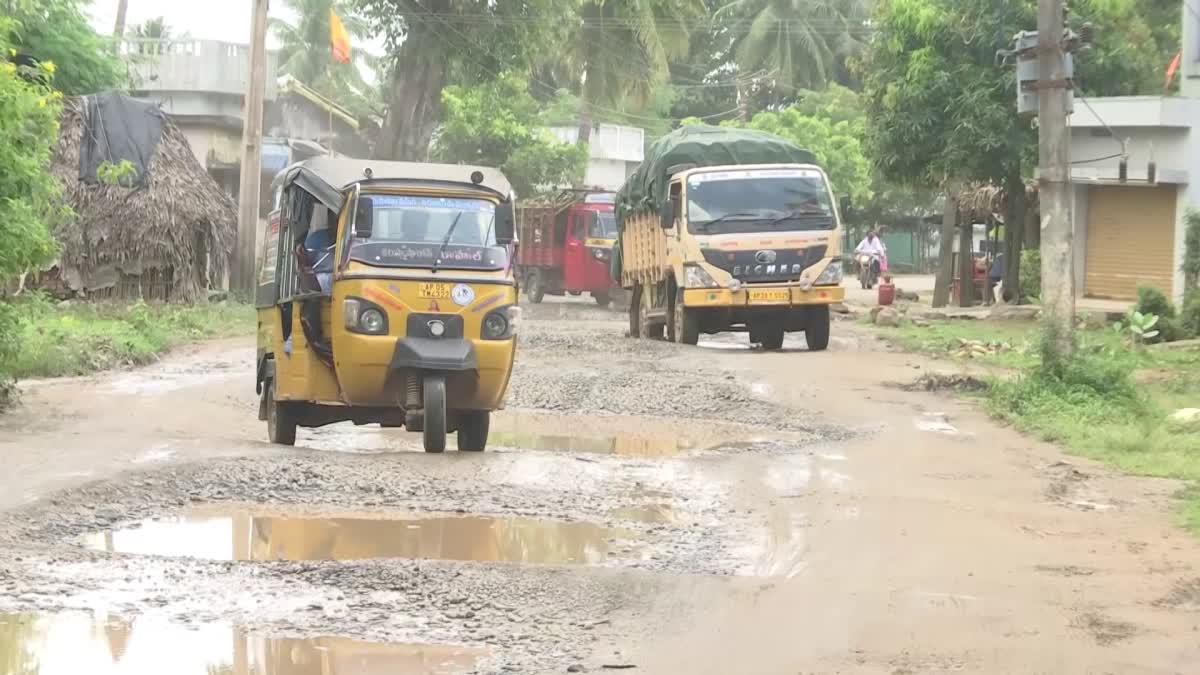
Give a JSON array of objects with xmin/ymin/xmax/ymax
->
[{"xmin": 84, "ymin": 509, "xmax": 631, "ymax": 565}]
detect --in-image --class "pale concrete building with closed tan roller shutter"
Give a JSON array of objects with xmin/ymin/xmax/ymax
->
[{"xmin": 1070, "ymin": 7, "xmax": 1200, "ymax": 303}]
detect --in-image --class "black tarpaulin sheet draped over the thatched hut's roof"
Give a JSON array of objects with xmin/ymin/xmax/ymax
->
[{"xmin": 79, "ymin": 91, "xmax": 166, "ymax": 187}]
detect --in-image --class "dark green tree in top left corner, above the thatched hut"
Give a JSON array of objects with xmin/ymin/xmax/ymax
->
[{"xmin": 8, "ymin": 0, "xmax": 125, "ymax": 95}]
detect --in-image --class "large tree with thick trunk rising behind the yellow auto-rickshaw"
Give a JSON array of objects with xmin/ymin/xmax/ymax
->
[{"xmin": 355, "ymin": 0, "xmax": 578, "ymax": 160}]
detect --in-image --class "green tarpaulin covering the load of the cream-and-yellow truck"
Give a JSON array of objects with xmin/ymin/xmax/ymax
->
[{"xmin": 617, "ymin": 126, "xmax": 816, "ymax": 229}]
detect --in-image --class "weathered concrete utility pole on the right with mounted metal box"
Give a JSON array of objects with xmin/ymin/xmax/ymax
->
[{"xmin": 1032, "ymin": 0, "xmax": 1075, "ymax": 356}]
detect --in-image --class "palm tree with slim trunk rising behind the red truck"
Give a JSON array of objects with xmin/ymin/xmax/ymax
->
[{"xmin": 570, "ymin": 0, "xmax": 706, "ymax": 145}]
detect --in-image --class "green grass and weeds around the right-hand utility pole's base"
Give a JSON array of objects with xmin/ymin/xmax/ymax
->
[{"xmin": 878, "ymin": 321, "xmax": 1200, "ymax": 533}]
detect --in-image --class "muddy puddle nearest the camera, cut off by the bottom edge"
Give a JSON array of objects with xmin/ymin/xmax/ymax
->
[{"xmin": 0, "ymin": 614, "xmax": 484, "ymax": 675}]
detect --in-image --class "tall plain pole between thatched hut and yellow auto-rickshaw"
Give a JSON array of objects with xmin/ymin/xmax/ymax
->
[{"xmin": 229, "ymin": 0, "xmax": 270, "ymax": 294}]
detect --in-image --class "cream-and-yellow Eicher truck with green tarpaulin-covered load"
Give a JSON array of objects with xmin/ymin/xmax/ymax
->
[{"xmin": 612, "ymin": 126, "xmax": 845, "ymax": 351}]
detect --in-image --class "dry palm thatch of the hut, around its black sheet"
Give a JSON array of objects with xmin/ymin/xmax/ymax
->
[{"xmin": 52, "ymin": 98, "xmax": 238, "ymax": 300}]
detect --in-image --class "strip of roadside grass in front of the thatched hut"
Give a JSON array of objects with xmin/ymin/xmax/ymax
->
[{"xmin": 0, "ymin": 294, "xmax": 256, "ymax": 378}]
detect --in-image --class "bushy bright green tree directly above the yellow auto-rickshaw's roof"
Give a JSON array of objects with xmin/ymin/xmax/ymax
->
[{"xmin": 433, "ymin": 73, "xmax": 587, "ymax": 197}]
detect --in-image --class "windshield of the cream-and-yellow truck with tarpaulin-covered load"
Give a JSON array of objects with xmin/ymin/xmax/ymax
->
[{"xmin": 688, "ymin": 169, "xmax": 834, "ymax": 234}]
